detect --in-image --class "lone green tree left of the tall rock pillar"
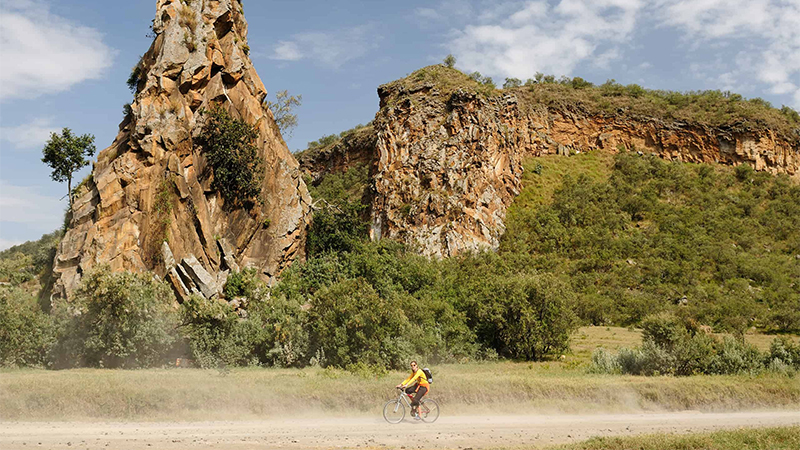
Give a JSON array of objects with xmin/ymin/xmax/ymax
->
[{"xmin": 42, "ymin": 128, "xmax": 96, "ymax": 210}]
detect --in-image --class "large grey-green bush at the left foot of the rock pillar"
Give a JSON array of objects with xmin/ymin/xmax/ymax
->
[{"xmin": 56, "ymin": 266, "xmax": 178, "ymax": 368}]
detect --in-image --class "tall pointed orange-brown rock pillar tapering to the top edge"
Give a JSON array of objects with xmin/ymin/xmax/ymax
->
[{"xmin": 54, "ymin": 0, "xmax": 310, "ymax": 297}]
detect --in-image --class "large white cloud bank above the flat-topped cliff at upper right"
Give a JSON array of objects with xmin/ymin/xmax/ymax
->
[{"xmin": 444, "ymin": 0, "xmax": 800, "ymax": 107}]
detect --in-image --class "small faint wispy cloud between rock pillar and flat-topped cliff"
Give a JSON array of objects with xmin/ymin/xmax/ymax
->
[{"xmin": 270, "ymin": 25, "xmax": 380, "ymax": 68}]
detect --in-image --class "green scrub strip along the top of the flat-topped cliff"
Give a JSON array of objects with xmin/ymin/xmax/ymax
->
[{"xmin": 385, "ymin": 65, "xmax": 800, "ymax": 142}]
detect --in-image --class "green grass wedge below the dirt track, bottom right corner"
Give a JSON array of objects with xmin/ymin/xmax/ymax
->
[{"xmin": 550, "ymin": 427, "xmax": 800, "ymax": 450}]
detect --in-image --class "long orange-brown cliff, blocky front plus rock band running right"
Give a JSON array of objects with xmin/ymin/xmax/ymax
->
[{"xmin": 301, "ymin": 66, "xmax": 800, "ymax": 257}]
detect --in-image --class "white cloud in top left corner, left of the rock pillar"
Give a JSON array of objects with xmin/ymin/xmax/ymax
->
[{"xmin": 0, "ymin": 0, "xmax": 115, "ymax": 100}]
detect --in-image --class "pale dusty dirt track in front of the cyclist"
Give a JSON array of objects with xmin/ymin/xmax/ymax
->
[{"xmin": 0, "ymin": 411, "xmax": 800, "ymax": 450}]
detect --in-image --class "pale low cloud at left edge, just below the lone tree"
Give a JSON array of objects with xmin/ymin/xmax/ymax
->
[{"xmin": 0, "ymin": 181, "xmax": 67, "ymax": 231}]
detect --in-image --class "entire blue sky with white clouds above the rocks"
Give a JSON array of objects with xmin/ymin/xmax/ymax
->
[{"xmin": 0, "ymin": 0, "xmax": 800, "ymax": 250}]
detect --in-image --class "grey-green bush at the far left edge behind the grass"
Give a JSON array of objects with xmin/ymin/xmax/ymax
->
[{"xmin": 0, "ymin": 287, "xmax": 55, "ymax": 367}]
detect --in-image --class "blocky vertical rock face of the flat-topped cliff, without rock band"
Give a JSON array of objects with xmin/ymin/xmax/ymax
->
[{"xmin": 371, "ymin": 85, "xmax": 523, "ymax": 257}]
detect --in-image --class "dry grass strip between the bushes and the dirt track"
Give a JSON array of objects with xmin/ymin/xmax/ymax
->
[{"xmin": 0, "ymin": 327, "xmax": 800, "ymax": 421}]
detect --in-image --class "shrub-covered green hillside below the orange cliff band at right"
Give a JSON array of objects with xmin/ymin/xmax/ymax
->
[{"xmin": 500, "ymin": 153, "xmax": 800, "ymax": 333}]
